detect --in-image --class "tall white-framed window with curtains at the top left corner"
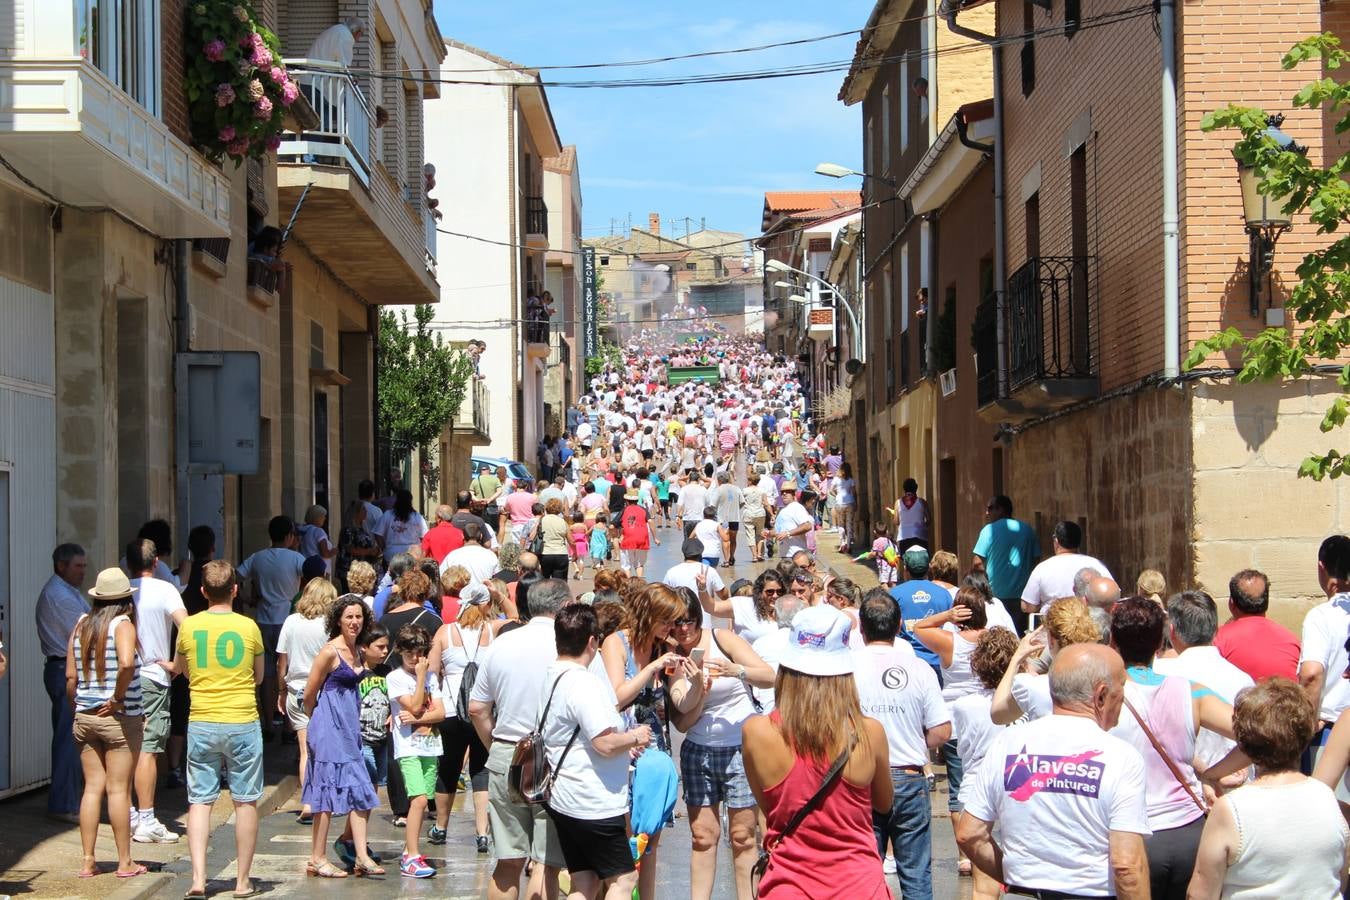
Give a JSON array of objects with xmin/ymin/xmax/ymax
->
[{"xmin": 74, "ymin": 0, "xmax": 159, "ymax": 116}]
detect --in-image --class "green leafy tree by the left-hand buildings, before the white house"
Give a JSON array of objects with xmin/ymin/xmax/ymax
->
[{"xmin": 375, "ymin": 306, "xmax": 474, "ymax": 447}]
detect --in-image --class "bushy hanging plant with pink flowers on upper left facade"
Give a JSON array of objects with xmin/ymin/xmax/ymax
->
[{"xmin": 184, "ymin": 0, "xmax": 300, "ymax": 166}]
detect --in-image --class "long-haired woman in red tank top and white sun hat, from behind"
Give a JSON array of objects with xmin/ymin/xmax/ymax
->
[{"xmin": 743, "ymin": 604, "xmax": 892, "ymax": 900}]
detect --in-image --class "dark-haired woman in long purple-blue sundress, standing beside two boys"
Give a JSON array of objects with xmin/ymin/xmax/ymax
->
[{"xmin": 301, "ymin": 595, "xmax": 385, "ymax": 878}]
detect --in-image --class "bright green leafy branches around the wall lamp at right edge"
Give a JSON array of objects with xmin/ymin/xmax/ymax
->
[{"xmin": 1184, "ymin": 34, "xmax": 1350, "ymax": 480}]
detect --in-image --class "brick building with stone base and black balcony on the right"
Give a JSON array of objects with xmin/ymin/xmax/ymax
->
[{"xmin": 928, "ymin": 0, "xmax": 1350, "ymax": 623}]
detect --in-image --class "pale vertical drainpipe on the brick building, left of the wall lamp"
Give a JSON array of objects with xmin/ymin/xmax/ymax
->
[{"xmin": 1158, "ymin": 0, "xmax": 1181, "ymax": 378}]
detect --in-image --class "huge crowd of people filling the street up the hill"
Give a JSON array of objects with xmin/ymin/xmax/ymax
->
[{"xmin": 26, "ymin": 325, "xmax": 1350, "ymax": 900}]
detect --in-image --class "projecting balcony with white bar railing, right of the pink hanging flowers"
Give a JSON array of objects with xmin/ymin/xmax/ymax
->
[{"xmin": 277, "ymin": 58, "xmax": 440, "ymax": 304}]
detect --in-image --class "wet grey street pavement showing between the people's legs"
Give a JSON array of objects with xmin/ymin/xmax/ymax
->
[{"xmin": 153, "ymin": 518, "xmax": 971, "ymax": 900}]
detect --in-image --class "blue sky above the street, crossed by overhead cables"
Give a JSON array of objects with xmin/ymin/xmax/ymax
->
[{"xmin": 436, "ymin": 0, "xmax": 873, "ymax": 237}]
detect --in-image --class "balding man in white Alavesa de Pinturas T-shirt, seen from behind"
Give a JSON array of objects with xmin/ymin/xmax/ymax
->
[{"xmin": 956, "ymin": 644, "xmax": 1152, "ymax": 900}]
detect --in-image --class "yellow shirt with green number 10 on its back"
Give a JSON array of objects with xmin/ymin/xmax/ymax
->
[{"xmin": 178, "ymin": 611, "xmax": 262, "ymax": 725}]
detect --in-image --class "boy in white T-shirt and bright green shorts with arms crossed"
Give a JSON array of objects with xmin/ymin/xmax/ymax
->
[{"xmin": 385, "ymin": 625, "xmax": 446, "ymax": 878}]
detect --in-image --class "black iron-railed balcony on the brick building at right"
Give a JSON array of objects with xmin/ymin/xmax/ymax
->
[{"xmin": 975, "ymin": 256, "xmax": 1099, "ymax": 421}]
